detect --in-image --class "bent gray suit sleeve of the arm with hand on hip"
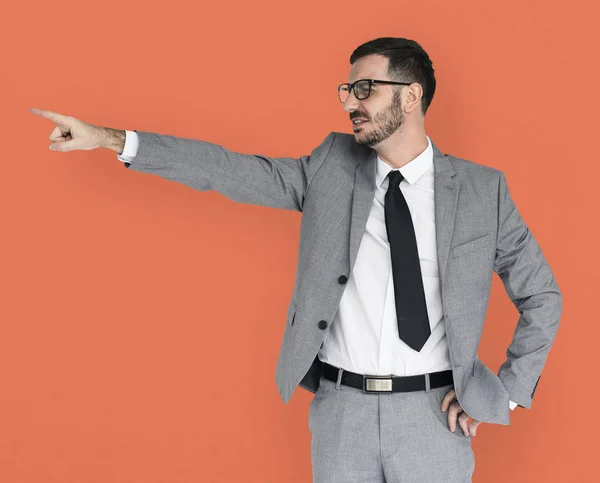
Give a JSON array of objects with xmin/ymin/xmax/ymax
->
[{"xmin": 494, "ymin": 172, "xmax": 562, "ymax": 409}]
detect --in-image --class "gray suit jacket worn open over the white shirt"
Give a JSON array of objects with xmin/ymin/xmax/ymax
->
[{"xmin": 125, "ymin": 131, "xmax": 562, "ymax": 425}]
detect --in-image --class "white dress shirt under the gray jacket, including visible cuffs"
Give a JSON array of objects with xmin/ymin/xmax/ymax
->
[{"xmin": 118, "ymin": 131, "xmax": 517, "ymax": 410}]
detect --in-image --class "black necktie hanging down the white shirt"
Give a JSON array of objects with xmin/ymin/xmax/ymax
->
[{"xmin": 385, "ymin": 170, "xmax": 431, "ymax": 352}]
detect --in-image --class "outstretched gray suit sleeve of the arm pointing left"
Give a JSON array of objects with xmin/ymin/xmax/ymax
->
[{"xmin": 125, "ymin": 131, "xmax": 335, "ymax": 211}]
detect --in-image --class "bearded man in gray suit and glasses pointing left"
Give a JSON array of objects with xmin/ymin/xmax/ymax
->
[{"xmin": 34, "ymin": 38, "xmax": 562, "ymax": 482}]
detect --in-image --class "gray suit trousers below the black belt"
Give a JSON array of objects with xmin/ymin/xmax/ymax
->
[{"xmin": 308, "ymin": 377, "xmax": 475, "ymax": 483}]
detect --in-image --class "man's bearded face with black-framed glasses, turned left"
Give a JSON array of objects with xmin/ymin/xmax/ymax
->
[{"xmin": 344, "ymin": 55, "xmax": 404, "ymax": 148}]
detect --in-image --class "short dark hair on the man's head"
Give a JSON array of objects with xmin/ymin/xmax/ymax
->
[{"xmin": 350, "ymin": 37, "xmax": 435, "ymax": 115}]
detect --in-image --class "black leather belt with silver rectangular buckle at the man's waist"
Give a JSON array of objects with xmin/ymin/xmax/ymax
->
[{"xmin": 322, "ymin": 361, "xmax": 454, "ymax": 393}]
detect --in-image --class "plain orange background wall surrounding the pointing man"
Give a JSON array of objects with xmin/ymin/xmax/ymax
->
[{"xmin": 0, "ymin": 0, "xmax": 600, "ymax": 483}]
